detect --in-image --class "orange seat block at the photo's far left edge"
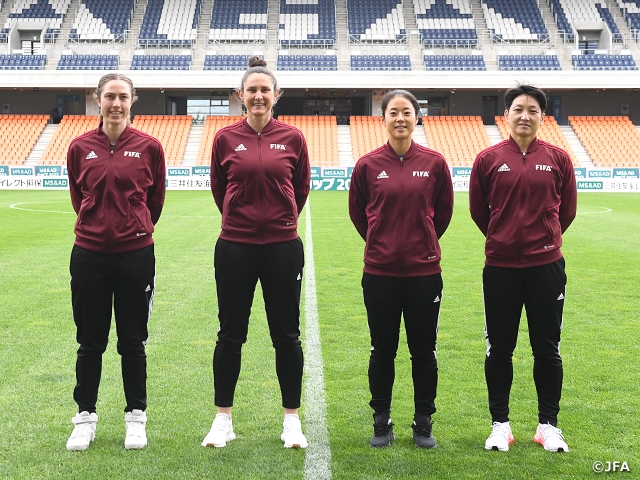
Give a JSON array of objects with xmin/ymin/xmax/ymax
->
[{"xmin": 0, "ymin": 115, "xmax": 49, "ymax": 165}]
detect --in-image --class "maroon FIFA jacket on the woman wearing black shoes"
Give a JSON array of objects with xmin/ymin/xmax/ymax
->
[{"xmin": 349, "ymin": 142, "xmax": 453, "ymax": 277}]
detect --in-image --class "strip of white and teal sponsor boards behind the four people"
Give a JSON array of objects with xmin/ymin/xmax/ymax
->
[{"xmin": 0, "ymin": 165, "xmax": 640, "ymax": 192}]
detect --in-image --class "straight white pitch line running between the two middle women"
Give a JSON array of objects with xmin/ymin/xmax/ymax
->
[{"xmin": 303, "ymin": 199, "xmax": 331, "ymax": 480}]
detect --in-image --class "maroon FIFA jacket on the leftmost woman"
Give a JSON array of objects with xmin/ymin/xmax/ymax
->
[{"xmin": 67, "ymin": 124, "xmax": 167, "ymax": 253}]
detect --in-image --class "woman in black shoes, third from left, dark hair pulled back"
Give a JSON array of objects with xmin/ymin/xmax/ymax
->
[{"xmin": 349, "ymin": 90, "xmax": 453, "ymax": 448}]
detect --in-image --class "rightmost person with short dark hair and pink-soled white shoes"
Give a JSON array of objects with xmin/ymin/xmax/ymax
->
[{"xmin": 469, "ymin": 85, "xmax": 577, "ymax": 452}]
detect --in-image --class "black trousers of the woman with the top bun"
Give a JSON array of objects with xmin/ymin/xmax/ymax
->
[{"xmin": 213, "ymin": 238, "xmax": 304, "ymax": 409}]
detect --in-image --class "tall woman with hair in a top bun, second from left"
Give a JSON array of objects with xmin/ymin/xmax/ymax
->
[{"xmin": 202, "ymin": 57, "xmax": 311, "ymax": 448}]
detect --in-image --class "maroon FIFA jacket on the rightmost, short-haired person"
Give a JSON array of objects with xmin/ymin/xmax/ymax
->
[{"xmin": 469, "ymin": 137, "xmax": 578, "ymax": 268}]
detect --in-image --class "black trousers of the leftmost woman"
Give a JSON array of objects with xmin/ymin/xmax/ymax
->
[{"xmin": 69, "ymin": 245, "xmax": 156, "ymax": 412}]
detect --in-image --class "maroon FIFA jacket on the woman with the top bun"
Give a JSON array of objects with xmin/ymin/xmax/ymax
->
[{"xmin": 211, "ymin": 118, "xmax": 311, "ymax": 244}]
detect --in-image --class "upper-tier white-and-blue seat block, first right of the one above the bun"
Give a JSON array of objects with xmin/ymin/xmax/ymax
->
[{"xmin": 278, "ymin": 0, "xmax": 336, "ymax": 46}]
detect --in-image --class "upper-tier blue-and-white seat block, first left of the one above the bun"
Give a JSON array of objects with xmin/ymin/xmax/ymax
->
[{"xmin": 138, "ymin": 0, "xmax": 202, "ymax": 46}]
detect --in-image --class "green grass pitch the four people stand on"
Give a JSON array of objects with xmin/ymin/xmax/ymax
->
[{"xmin": 0, "ymin": 191, "xmax": 640, "ymax": 480}]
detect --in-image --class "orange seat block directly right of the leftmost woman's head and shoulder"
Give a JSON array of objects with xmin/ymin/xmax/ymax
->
[{"xmin": 131, "ymin": 115, "xmax": 193, "ymax": 165}]
